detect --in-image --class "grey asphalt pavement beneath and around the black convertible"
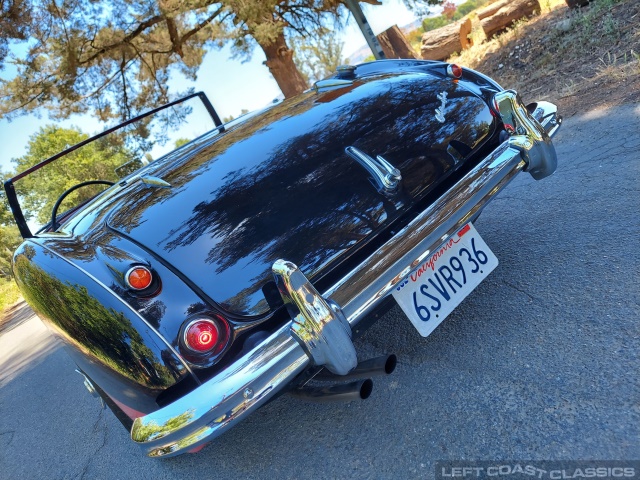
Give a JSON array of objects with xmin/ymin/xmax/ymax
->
[{"xmin": 0, "ymin": 104, "xmax": 640, "ymax": 480}]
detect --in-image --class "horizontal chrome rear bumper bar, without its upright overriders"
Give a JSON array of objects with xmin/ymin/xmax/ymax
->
[{"xmin": 131, "ymin": 96, "xmax": 555, "ymax": 457}]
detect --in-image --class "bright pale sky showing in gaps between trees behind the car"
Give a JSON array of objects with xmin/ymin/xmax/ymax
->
[{"xmin": 0, "ymin": 0, "xmax": 430, "ymax": 171}]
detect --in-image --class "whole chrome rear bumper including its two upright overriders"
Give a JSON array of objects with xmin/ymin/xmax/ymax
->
[{"xmin": 131, "ymin": 91, "xmax": 561, "ymax": 457}]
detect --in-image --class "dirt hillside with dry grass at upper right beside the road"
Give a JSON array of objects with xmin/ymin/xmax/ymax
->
[{"xmin": 458, "ymin": 0, "xmax": 640, "ymax": 117}]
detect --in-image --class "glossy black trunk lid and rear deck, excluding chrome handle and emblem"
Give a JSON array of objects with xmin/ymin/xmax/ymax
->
[{"xmin": 108, "ymin": 73, "xmax": 495, "ymax": 317}]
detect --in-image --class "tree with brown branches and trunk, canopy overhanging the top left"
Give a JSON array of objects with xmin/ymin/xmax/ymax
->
[{"xmin": 0, "ymin": 0, "xmax": 450, "ymax": 122}]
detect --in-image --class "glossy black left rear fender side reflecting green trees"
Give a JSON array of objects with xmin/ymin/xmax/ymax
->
[{"xmin": 14, "ymin": 240, "xmax": 191, "ymax": 417}]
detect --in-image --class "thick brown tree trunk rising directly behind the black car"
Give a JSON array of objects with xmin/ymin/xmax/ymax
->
[{"xmin": 258, "ymin": 33, "xmax": 307, "ymax": 98}]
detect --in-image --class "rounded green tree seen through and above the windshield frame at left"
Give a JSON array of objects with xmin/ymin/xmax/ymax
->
[{"xmin": 13, "ymin": 125, "xmax": 133, "ymax": 225}]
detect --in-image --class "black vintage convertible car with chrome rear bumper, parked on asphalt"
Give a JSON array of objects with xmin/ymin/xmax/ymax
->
[{"xmin": 5, "ymin": 60, "xmax": 561, "ymax": 457}]
